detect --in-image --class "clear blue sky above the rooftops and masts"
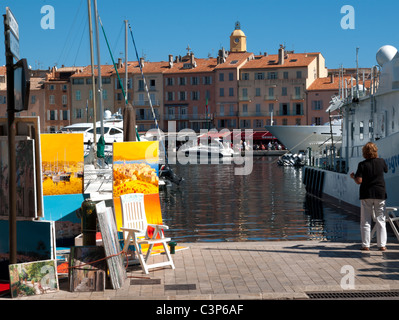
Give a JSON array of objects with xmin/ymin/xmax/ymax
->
[{"xmin": 0, "ymin": 0, "xmax": 399, "ymax": 69}]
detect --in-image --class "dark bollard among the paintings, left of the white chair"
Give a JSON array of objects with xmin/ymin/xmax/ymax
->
[{"xmin": 80, "ymin": 199, "xmax": 97, "ymax": 246}]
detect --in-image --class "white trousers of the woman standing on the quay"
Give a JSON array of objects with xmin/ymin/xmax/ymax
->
[{"xmin": 360, "ymin": 199, "xmax": 387, "ymax": 248}]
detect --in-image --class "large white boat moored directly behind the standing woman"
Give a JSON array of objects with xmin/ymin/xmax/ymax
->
[{"xmin": 303, "ymin": 46, "xmax": 399, "ymax": 207}]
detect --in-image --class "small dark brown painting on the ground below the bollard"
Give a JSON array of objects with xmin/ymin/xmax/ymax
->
[{"xmin": 69, "ymin": 246, "xmax": 107, "ymax": 292}]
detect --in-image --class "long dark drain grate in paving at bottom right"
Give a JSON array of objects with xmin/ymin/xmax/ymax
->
[{"xmin": 306, "ymin": 290, "xmax": 399, "ymax": 300}]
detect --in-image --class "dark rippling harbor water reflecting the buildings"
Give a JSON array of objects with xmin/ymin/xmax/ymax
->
[{"xmin": 160, "ymin": 156, "xmax": 396, "ymax": 243}]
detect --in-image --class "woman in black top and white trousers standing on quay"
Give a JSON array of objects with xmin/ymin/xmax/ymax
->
[{"xmin": 350, "ymin": 142, "xmax": 388, "ymax": 251}]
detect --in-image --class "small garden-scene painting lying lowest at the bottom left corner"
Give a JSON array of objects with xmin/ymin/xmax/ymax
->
[{"xmin": 9, "ymin": 260, "xmax": 59, "ymax": 298}]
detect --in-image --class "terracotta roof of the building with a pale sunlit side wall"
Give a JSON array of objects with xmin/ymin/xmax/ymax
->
[{"xmin": 242, "ymin": 53, "xmax": 319, "ymax": 69}]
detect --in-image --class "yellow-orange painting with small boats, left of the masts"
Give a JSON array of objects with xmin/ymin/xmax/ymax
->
[{"xmin": 40, "ymin": 133, "xmax": 84, "ymax": 196}]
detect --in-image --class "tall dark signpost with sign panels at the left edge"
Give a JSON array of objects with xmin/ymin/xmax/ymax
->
[{"xmin": 3, "ymin": 7, "xmax": 30, "ymax": 264}]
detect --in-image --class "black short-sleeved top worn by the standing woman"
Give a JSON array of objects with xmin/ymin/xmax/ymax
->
[{"xmin": 355, "ymin": 158, "xmax": 388, "ymax": 200}]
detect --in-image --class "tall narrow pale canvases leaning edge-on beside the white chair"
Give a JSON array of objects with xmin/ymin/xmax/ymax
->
[{"xmin": 96, "ymin": 201, "xmax": 127, "ymax": 289}]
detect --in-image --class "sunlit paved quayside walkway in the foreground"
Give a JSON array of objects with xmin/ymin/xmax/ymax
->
[{"xmin": 3, "ymin": 241, "xmax": 399, "ymax": 300}]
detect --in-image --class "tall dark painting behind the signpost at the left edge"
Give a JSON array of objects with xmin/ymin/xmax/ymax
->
[{"xmin": 0, "ymin": 139, "xmax": 37, "ymax": 219}]
